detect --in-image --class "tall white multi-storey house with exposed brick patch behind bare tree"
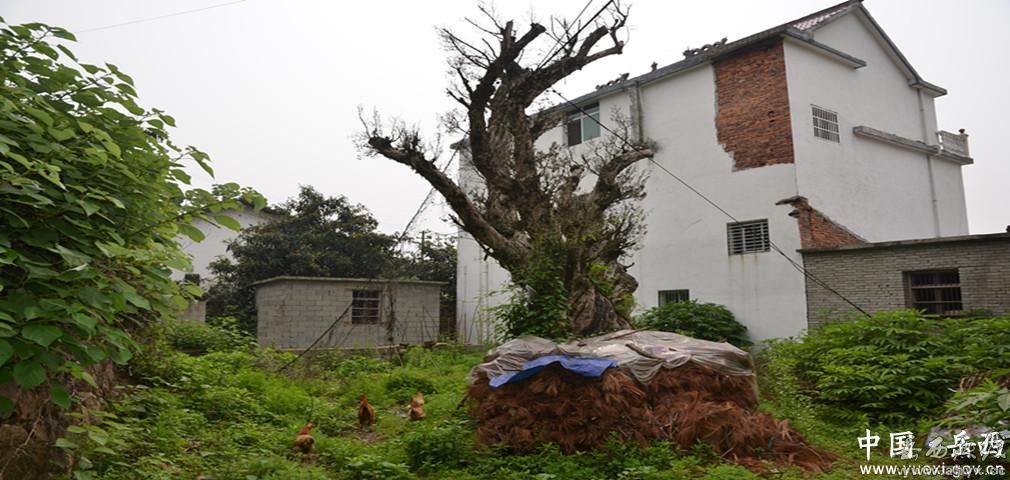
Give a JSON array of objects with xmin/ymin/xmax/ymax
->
[{"xmin": 457, "ymin": 1, "xmax": 972, "ymax": 343}]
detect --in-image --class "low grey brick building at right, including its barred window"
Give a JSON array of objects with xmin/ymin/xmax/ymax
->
[{"xmin": 800, "ymin": 233, "xmax": 1010, "ymax": 326}]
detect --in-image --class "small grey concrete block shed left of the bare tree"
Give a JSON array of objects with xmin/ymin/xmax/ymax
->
[{"xmin": 254, "ymin": 277, "xmax": 445, "ymax": 350}]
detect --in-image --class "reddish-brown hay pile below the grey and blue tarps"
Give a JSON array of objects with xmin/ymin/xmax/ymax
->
[{"xmin": 468, "ymin": 333, "xmax": 836, "ymax": 471}]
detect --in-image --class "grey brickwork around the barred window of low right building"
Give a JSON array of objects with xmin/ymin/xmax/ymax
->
[{"xmin": 803, "ymin": 234, "xmax": 1010, "ymax": 326}]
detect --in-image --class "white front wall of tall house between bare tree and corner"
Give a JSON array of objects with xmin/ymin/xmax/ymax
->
[{"xmin": 631, "ymin": 66, "xmax": 806, "ymax": 341}]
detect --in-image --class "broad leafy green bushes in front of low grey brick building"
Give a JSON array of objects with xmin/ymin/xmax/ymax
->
[{"xmin": 769, "ymin": 310, "xmax": 1010, "ymax": 422}]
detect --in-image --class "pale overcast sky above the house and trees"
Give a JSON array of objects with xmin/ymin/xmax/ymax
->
[{"xmin": 0, "ymin": 0, "xmax": 1010, "ymax": 233}]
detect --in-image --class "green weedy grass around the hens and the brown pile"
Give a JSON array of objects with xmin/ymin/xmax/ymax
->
[{"xmin": 57, "ymin": 321, "xmax": 925, "ymax": 480}]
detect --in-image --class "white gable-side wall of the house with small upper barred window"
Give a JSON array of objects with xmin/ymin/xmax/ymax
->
[{"xmin": 786, "ymin": 14, "xmax": 968, "ymax": 242}]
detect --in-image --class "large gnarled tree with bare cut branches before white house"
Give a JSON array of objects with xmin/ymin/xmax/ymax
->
[{"xmin": 364, "ymin": 1, "xmax": 652, "ymax": 337}]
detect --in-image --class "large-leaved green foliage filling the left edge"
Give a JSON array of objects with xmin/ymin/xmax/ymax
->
[{"xmin": 0, "ymin": 19, "xmax": 263, "ymax": 415}]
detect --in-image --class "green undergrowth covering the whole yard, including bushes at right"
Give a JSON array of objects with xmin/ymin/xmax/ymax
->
[{"xmin": 51, "ymin": 311, "xmax": 1010, "ymax": 480}]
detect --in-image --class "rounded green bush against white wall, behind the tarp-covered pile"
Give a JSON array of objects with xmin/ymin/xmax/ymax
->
[{"xmin": 635, "ymin": 300, "xmax": 750, "ymax": 347}]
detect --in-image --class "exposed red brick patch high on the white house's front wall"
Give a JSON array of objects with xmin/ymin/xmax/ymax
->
[{"xmin": 713, "ymin": 38, "xmax": 793, "ymax": 170}]
